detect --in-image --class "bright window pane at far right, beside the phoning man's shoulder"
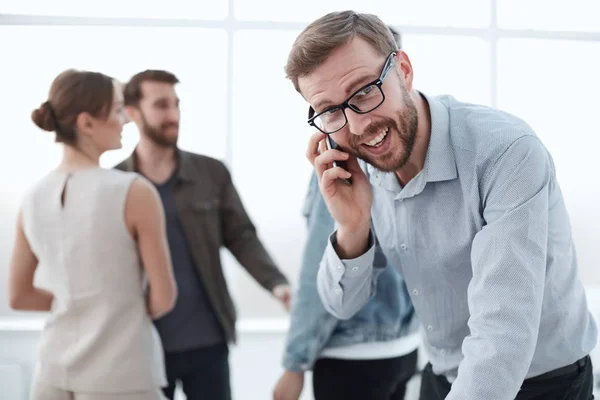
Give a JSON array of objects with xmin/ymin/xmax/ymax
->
[{"xmin": 498, "ymin": 39, "xmax": 600, "ymax": 285}]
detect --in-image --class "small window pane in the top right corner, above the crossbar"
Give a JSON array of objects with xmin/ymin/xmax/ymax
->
[{"xmin": 498, "ymin": 0, "xmax": 600, "ymax": 31}]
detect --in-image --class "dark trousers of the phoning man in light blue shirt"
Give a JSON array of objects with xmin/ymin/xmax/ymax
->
[{"xmin": 420, "ymin": 357, "xmax": 594, "ymax": 400}]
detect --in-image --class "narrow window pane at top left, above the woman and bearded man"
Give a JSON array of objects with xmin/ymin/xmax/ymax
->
[{"xmin": 0, "ymin": 0, "xmax": 227, "ymax": 20}]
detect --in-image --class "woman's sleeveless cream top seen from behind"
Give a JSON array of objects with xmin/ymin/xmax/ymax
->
[{"xmin": 22, "ymin": 168, "xmax": 166, "ymax": 393}]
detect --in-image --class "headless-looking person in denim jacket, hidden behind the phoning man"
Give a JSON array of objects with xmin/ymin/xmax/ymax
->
[{"xmin": 274, "ymin": 170, "xmax": 420, "ymax": 400}]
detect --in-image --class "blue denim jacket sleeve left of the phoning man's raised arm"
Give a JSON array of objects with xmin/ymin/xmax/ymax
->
[{"xmin": 283, "ymin": 174, "xmax": 338, "ymax": 372}]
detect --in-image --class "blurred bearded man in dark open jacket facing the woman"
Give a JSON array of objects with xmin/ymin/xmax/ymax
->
[{"xmin": 116, "ymin": 70, "xmax": 290, "ymax": 400}]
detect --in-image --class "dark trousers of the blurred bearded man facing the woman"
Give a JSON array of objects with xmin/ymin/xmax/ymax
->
[{"xmin": 163, "ymin": 343, "xmax": 231, "ymax": 400}]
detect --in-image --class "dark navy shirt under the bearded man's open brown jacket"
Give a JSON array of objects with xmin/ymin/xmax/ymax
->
[{"xmin": 155, "ymin": 174, "xmax": 225, "ymax": 353}]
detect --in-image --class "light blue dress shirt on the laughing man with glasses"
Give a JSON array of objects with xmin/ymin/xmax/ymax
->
[{"xmin": 317, "ymin": 92, "xmax": 597, "ymax": 400}]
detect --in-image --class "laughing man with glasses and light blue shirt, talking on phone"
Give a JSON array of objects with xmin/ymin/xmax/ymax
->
[{"xmin": 286, "ymin": 11, "xmax": 597, "ymax": 400}]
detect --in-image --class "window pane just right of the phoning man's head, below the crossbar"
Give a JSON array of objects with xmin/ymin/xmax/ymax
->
[{"xmin": 402, "ymin": 35, "xmax": 491, "ymax": 104}]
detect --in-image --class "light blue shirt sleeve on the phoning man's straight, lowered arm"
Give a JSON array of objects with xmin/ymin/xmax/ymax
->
[{"xmin": 446, "ymin": 136, "xmax": 555, "ymax": 400}]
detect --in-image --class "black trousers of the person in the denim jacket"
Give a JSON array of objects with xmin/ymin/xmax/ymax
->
[{"xmin": 313, "ymin": 350, "xmax": 417, "ymax": 400}]
